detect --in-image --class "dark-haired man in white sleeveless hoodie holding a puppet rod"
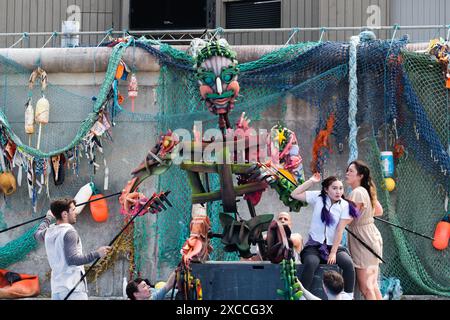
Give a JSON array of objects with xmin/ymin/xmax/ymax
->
[{"xmin": 34, "ymin": 198, "xmax": 111, "ymax": 300}]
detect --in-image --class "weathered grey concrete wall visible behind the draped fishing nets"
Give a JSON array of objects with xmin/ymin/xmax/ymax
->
[{"xmin": 0, "ymin": 48, "xmax": 358, "ymax": 296}]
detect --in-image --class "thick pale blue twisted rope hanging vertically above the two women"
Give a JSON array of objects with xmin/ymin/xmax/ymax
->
[{"xmin": 348, "ymin": 36, "xmax": 359, "ymax": 163}]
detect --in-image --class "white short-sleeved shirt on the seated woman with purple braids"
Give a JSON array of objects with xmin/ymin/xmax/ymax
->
[{"xmin": 305, "ymin": 191, "xmax": 352, "ymax": 246}]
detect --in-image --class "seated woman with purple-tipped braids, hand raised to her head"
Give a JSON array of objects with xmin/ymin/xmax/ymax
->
[{"xmin": 291, "ymin": 173, "xmax": 358, "ymax": 295}]
